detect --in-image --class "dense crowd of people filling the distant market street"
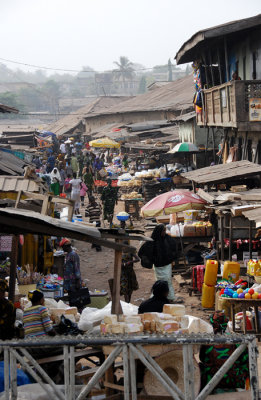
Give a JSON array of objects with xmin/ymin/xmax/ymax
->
[{"xmin": 32, "ymin": 139, "xmax": 119, "ymax": 226}]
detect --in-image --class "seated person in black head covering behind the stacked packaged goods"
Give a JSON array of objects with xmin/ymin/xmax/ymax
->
[{"xmin": 139, "ymin": 281, "xmax": 169, "ymax": 314}]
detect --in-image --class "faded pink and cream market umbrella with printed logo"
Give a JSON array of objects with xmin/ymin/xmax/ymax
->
[{"xmin": 141, "ymin": 190, "xmax": 206, "ymax": 217}]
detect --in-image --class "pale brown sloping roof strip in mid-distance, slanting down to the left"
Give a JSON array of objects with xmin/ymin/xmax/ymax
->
[{"xmin": 48, "ymin": 96, "xmax": 129, "ymax": 136}]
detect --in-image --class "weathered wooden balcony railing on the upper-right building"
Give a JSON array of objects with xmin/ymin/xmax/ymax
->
[{"xmin": 197, "ymin": 80, "xmax": 261, "ymax": 131}]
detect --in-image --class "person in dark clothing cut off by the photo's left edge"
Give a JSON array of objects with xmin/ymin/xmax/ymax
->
[{"xmin": 0, "ymin": 279, "xmax": 15, "ymax": 340}]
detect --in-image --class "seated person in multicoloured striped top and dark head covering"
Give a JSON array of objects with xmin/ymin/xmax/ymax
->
[{"xmin": 23, "ymin": 289, "xmax": 55, "ymax": 337}]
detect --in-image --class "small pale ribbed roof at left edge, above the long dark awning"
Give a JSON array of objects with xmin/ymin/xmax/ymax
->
[{"xmin": 0, "ymin": 175, "xmax": 44, "ymax": 193}]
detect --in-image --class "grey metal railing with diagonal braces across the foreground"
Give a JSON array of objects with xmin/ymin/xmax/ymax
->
[{"xmin": 0, "ymin": 334, "xmax": 259, "ymax": 400}]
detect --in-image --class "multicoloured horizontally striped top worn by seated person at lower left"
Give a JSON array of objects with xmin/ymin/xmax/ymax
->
[{"xmin": 24, "ymin": 305, "xmax": 52, "ymax": 337}]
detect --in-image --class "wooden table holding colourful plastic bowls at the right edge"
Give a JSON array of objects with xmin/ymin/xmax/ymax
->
[{"xmin": 227, "ymin": 298, "xmax": 261, "ymax": 338}]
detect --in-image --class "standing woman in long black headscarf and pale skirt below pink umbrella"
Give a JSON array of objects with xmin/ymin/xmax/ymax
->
[{"xmin": 151, "ymin": 224, "xmax": 183, "ymax": 303}]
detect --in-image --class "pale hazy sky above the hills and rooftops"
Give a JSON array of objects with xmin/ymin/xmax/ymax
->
[{"xmin": 0, "ymin": 0, "xmax": 261, "ymax": 74}]
